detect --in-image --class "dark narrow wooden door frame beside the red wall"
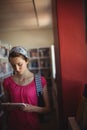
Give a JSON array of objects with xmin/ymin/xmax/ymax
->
[{"xmin": 52, "ymin": 0, "xmax": 67, "ymax": 130}]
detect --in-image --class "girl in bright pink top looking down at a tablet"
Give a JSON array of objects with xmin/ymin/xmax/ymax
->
[{"xmin": 3, "ymin": 46, "xmax": 50, "ymax": 130}]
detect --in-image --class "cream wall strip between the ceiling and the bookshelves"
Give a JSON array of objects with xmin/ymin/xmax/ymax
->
[{"xmin": 0, "ymin": 29, "xmax": 54, "ymax": 49}]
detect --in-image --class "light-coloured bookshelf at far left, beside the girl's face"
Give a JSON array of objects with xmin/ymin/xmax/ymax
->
[{"xmin": 0, "ymin": 40, "xmax": 12, "ymax": 105}]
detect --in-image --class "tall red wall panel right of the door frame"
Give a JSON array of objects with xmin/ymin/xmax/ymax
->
[{"xmin": 57, "ymin": 0, "xmax": 87, "ymax": 115}]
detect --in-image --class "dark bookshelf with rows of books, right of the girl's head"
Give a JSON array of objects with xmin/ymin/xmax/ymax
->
[{"xmin": 28, "ymin": 47, "xmax": 52, "ymax": 87}]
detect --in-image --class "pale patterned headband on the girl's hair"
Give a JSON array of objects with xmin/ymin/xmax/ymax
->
[{"xmin": 9, "ymin": 46, "xmax": 29, "ymax": 58}]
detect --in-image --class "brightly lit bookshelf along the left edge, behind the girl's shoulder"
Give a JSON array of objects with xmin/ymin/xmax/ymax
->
[{"xmin": 0, "ymin": 40, "xmax": 12, "ymax": 130}]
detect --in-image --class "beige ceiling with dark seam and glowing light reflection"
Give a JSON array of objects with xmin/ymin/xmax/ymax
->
[{"xmin": 0, "ymin": 0, "xmax": 52, "ymax": 31}]
